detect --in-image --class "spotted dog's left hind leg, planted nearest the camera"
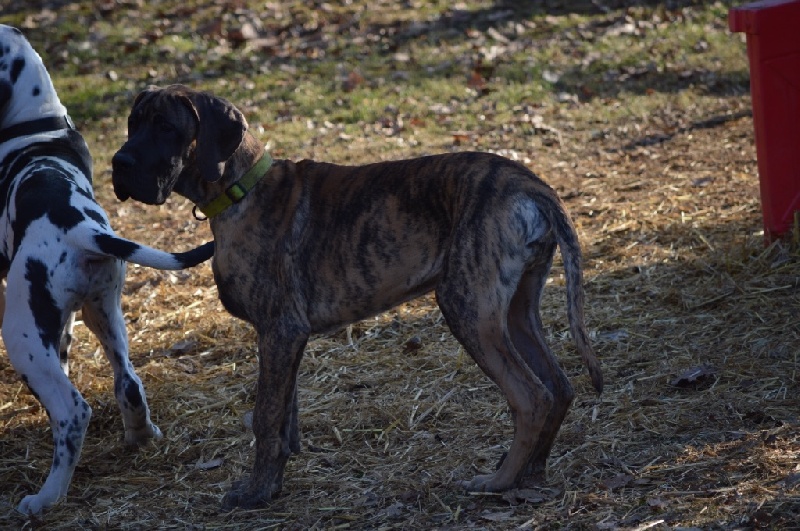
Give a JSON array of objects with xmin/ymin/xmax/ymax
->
[{"xmin": 3, "ymin": 267, "xmax": 92, "ymax": 514}]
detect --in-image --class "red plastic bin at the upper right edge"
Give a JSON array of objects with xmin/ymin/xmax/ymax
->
[{"xmin": 728, "ymin": 0, "xmax": 800, "ymax": 241}]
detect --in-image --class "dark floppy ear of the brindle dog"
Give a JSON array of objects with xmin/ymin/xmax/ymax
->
[{"xmin": 188, "ymin": 92, "xmax": 247, "ymax": 181}]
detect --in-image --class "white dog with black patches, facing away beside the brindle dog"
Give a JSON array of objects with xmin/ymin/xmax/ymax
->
[{"xmin": 0, "ymin": 25, "xmax": 213, "ymax": 513}]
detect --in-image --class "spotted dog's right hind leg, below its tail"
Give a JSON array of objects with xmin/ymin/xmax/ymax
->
[{"xmin": 83, "ymin": 260, "xmax": 162, "ymax": 445}]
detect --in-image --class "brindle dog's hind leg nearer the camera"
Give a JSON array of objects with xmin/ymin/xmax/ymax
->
[{"xmin": 436, "ymin": 239, "xmax": 553, "ymax": 492}]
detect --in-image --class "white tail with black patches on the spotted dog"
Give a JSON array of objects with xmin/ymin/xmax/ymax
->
[{"xmin": 73, "ymin": 230, "xmax": 214, "ymax": 270}]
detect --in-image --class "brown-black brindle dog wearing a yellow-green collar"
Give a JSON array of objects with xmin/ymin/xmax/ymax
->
[{"xmin": 113, "ymin": 85, "xmax": 603, "ymax": 508}]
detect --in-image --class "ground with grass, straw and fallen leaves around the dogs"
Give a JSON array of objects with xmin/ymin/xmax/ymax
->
[{"xmin": 0, "ymin": 0, "xmax": 800, "ymax": 530}]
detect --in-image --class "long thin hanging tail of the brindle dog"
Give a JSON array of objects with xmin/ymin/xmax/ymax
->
[{"xmin": 538, "ymin": 185, "xmax": 603, "ymax": 394}]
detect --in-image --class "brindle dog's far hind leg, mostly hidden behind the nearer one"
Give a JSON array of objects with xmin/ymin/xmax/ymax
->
[{"xmin": 508, "ymin": 243, "xmax": 575, "ymax": 480}]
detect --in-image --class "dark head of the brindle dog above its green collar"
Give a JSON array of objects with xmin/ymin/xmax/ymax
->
[{"xmin": 111, "ymin": 85, "xmax": 247, "ymax": 205}]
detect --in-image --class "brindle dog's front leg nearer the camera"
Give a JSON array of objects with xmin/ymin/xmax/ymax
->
[{"xmin": 222, "ymin": 324, "xmax": 308, "ymax": 510}]
